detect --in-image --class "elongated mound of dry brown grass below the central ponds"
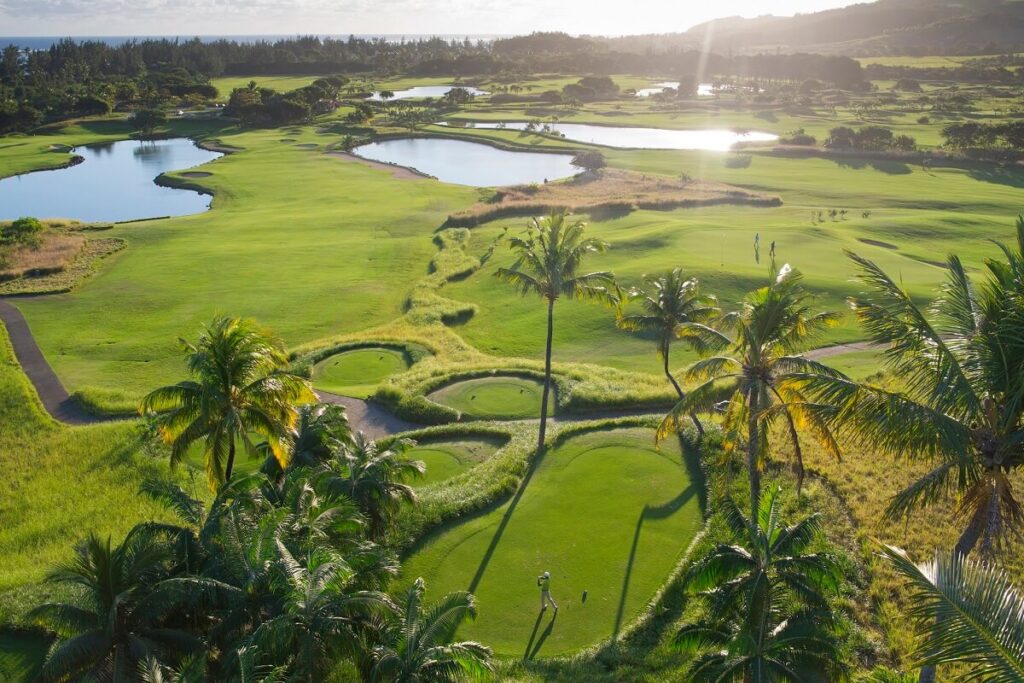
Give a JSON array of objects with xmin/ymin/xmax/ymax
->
[{"xmin": 445, "ymin": 169, "xmax": 782, "ymax": 227}]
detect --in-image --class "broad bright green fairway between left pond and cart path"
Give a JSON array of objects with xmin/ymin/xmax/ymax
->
[{"xmin": 6, "ymin": 120, "xmax": 477, "ymax": 397}]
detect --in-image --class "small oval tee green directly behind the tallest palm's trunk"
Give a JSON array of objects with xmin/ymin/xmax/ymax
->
[{"xmin": 427, "ymin": 376, "xmax": 555, "ymax": 418}]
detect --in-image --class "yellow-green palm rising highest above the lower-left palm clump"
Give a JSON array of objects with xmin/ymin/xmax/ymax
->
[{"xmin": 139, "ymin": 317, "xmax": 313, "ymax": 490}]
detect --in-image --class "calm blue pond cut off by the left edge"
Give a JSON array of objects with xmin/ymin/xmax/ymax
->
[{"xmin": 0, "ymin": 137, "xmax": 222, "ymax": 222}]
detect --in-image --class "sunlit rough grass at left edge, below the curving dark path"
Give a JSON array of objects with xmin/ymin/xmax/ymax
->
[{"xmin": 0, "ymin": 326, "xmax": 171, "ymax": 622}]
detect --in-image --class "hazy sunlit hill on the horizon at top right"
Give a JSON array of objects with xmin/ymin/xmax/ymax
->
[{"xmin": 606, "ymin": 0, "xmax": 1024, "ymax": 56}]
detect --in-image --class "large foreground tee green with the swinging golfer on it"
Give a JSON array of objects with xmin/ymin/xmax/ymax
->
[{"xmin": 402, "ymin": 428, "xmax": 702, "ymax": 657}]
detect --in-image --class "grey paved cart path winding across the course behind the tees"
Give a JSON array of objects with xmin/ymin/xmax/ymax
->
[{"xmin": 0, "ymin": 299, "xmax": 881, "ymax": 439}]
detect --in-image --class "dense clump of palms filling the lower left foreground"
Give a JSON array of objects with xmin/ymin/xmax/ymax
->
[{"xmin": 24, "ymin": 318, "xmax": 489, "ymax": 682}]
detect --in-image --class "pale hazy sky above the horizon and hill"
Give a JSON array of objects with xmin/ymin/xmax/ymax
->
[{"xmin": 0, "ymin": 0, "xmax": 854, "ymax": 36}]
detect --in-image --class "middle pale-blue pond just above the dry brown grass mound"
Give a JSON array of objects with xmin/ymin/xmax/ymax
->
[{"xmin": 352, "ymin": 137, "xmax": 580, "ymax": 187}]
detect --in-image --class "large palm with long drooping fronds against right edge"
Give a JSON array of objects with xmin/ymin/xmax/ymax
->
[{"xmin": 809, "ymin": 219, "xmax": 1024, "ymax": 556}]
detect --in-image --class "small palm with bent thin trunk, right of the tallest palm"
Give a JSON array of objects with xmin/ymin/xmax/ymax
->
[{"xmin": 616, "ymin": 268, "xmax": 718, "ymax": 435}]
